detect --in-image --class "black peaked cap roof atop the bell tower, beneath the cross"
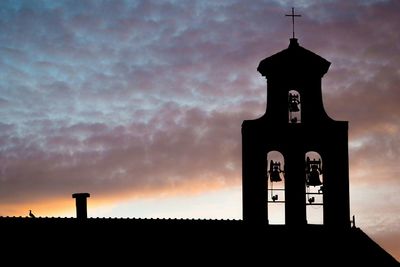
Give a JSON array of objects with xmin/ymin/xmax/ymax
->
[{"xmin": 257, "ymin": 38, "xmax": 331, "ymax": 79}]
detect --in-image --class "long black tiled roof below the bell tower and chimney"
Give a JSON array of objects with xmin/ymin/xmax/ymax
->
[{"xmin": 0, "ymin": 217, "xmax": 399, "ymax": 267}]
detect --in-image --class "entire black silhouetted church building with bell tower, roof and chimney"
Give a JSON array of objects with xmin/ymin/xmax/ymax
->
[{"xmin": 0, "ymin": 33, "xmax": 399, "ymax": 267}]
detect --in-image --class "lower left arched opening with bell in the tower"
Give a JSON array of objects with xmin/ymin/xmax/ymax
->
[{"xmin": 266, "ymin": 151, "xmax": 285, "ymax": 224}]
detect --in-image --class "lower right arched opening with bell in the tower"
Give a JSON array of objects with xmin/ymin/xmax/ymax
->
[{"xmin": 305, "ymin": 151, "xmax": 324, "ymax": 224}]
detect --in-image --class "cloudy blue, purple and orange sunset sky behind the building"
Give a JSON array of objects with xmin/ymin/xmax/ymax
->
[{"xmin": 0, "ymin": 0, "xmax": 400, "ymax": 259}]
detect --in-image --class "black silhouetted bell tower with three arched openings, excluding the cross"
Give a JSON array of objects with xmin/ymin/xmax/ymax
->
[{"xmin": 242, "ymin": 38, "xmax": 350, "ymax": 228}]
